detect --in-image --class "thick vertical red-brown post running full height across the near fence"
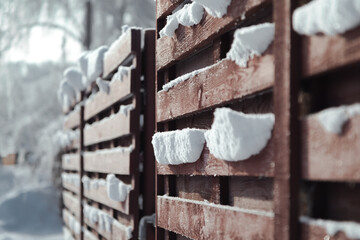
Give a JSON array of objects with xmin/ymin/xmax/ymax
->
[{"xmin": 273, "ymin": 0, "xmax": 301, "ymax": 240}]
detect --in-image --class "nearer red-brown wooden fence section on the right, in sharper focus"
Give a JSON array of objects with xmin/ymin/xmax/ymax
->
[{"xmin": 156, "ymin": 0, "xmax": 360, "ymax": 239}]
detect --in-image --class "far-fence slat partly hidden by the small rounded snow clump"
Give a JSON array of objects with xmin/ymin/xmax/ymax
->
[{"xmin": 84, "ymin": 186, "xmax": 132, "ymax": 214}]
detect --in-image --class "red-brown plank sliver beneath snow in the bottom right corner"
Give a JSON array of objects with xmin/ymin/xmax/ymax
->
[{"xmin": 301, "ymin": 223, "xmax": 355, "ymax": 240}]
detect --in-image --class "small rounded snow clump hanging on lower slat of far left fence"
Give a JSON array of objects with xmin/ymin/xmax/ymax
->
[{"xmin": 106, "ymin": 174, "xmax": 132, "ymax": 202}]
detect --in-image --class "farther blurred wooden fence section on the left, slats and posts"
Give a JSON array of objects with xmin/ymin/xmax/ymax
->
[{"xmin": 62, "ymin": 29, "xmax": 155, "ymax": 239}]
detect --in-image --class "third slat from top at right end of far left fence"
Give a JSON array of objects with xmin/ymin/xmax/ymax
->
[{"xmin": 84, "ymin": 112, "xmax": 130, "ymax": 146}]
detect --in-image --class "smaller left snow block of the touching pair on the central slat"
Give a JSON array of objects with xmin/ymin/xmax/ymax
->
[{"xmin": 151, "ymin": 128, "xmax": 205, "ymax": 165}]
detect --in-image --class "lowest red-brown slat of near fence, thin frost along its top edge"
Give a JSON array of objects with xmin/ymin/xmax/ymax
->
[{"xmin": 157, "ymin": 196, "xmax": 274, "ymax": 239}]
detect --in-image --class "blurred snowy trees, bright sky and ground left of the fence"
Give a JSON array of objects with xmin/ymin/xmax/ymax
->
[{"xmin": 0, "ymin": 0, "xmax": 155, "ymax": 239}]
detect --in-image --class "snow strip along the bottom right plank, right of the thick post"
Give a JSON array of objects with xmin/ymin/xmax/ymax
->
[{"xmin": 300, "ymin": 216, "xmax": 360, "ymax": 239}]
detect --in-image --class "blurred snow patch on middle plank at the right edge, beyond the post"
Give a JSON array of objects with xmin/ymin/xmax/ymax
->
[{"xmin": 316, "ymin": 103, "xmax": 360, "ymax": 134}]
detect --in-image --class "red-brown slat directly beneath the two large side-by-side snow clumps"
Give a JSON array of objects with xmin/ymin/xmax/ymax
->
[{"xmin": 157, "ymin": 139, "xmax": 274, "ymax": 177}]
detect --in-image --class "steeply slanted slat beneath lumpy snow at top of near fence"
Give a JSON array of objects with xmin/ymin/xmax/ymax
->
[{"xmin": 156, "ymin": 0, "xmax": 271, "ymax": 70}]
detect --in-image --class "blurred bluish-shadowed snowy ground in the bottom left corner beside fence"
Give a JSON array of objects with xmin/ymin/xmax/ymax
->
[{"xmin": 0, "ymin": 165, "xmax": 62, "ymax": 240}]
